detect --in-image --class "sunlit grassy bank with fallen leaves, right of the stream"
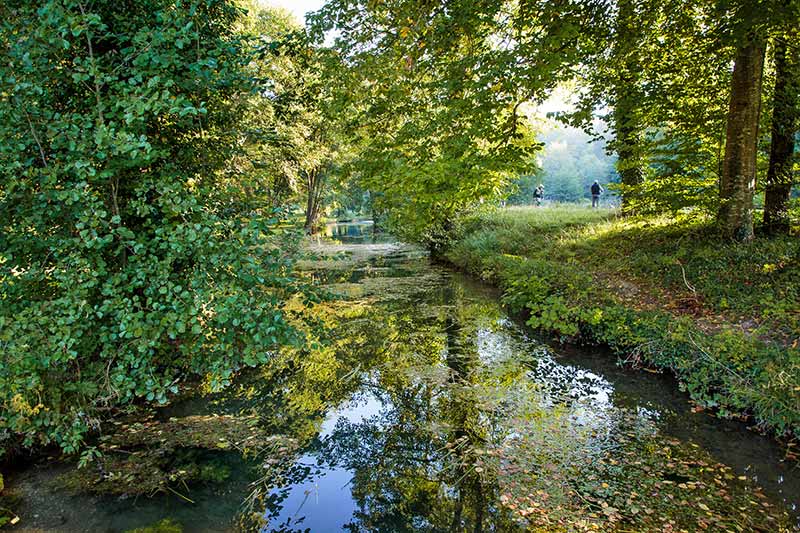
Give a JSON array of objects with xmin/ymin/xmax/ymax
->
[{"xmin": 445, "ymin": 207, "xmax": 800, "ymax": 437}]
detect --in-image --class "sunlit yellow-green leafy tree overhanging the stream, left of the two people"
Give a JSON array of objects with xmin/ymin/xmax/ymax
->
[{"xmin": 313, "ymin": 0, "xmax": 557, "ymax": 243}]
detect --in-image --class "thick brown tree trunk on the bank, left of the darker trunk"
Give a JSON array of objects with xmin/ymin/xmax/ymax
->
[{"xmin": 717, "ymin": 35, "xmax": 766, "ymax": 241}]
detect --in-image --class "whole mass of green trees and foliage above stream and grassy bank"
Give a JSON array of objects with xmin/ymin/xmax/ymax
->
[{"xmin": 0, "ymin": 0, "xmax": 800, "ymax": 450}]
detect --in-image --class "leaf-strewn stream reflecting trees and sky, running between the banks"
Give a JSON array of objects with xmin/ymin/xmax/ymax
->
[{"xmin": 5, "ymin": 223, "xmax": 800, "ymax": 533}]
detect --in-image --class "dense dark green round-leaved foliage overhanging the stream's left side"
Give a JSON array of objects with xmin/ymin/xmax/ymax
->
[{"xmin": 0, "ymin": 0, "xmax": 312, "ymax": 452}]
